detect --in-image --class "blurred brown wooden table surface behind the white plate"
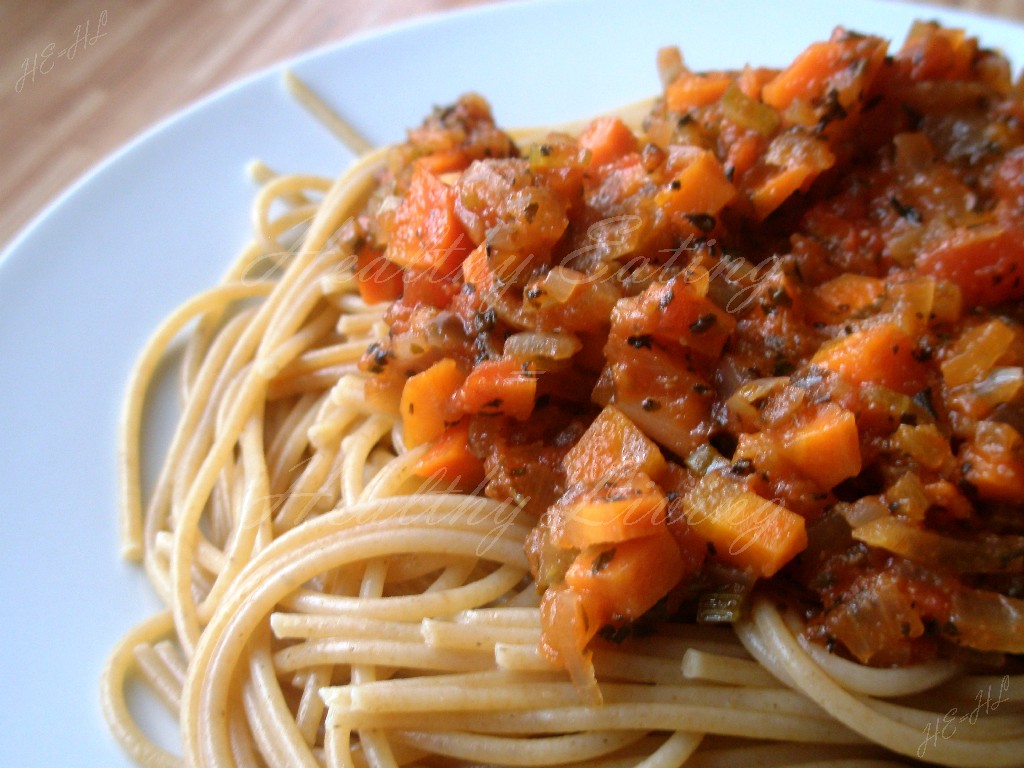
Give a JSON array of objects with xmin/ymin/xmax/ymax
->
[{"xmin": 0, "ymin": 0, "xmax": 1024, "ymax": 248}]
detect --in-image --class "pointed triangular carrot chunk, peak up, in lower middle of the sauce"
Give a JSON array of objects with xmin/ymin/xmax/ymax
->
[{"xmin": 562, "ymin": 406, "xmax": 666, "ymax": 486}]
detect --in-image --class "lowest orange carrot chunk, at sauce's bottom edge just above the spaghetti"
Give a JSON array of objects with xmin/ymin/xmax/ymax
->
[{"xmin": 565, "ymin": 526, "xmax": 684, "ymax": 621}]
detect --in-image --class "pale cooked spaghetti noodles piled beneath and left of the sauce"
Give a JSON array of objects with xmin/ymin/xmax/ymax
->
[{"xmin": 102, "ymin": 20, "xmax": 1024, "ymax": 768}]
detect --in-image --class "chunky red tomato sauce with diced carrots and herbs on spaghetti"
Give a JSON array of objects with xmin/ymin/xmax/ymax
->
[{"xmin": 356, "ymin": 23, "xmax": 1024, "ymax": 681}]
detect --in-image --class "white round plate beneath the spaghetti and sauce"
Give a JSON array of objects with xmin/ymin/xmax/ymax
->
[{"xmin": 0, "ymin": 0, "xmax": 1024, "ymax": 766}]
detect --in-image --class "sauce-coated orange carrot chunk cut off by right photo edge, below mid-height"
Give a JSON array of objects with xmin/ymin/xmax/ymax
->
[{"xmin": 958, "ymin": 421, "xmax": 1024, "ymax": 504}]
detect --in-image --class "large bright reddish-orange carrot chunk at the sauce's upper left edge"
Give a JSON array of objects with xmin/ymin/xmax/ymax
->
[{"xmin": 384, "ymin": 166, "xmax": 472, "ymax": 275}]
